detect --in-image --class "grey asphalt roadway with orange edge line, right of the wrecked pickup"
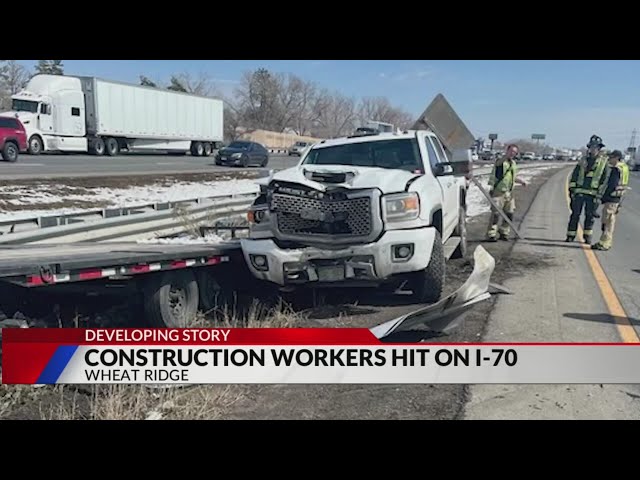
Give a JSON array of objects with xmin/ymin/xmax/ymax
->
[{"xmin": 464, "ymin": 169, "xmax": 640, "ymax": 419}]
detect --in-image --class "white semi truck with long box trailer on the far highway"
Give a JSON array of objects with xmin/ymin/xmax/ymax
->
[{"xmin": 0, "ymin": 75, "xmax": 224, "ymax": 156}]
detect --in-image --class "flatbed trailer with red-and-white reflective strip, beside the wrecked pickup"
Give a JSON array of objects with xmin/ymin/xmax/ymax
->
[{"xmin": 0, "ymin": 241, "xmax": 246, "ymax": 327}]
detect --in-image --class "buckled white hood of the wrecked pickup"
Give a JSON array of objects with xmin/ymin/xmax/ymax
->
[{"xmin": 272, "ymin": 165, "xmax": 420, "ymax": 193}]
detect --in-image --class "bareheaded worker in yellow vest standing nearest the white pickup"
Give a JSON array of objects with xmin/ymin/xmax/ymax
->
[{"xmin": 487, "ymin": 144, "xmax": 527, "ymax": 242}]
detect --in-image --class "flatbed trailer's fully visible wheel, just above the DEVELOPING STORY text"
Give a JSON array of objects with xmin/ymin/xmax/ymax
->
[{"xmin": 144, "ymin": 270, "xmax": 198, "ymax": 328}]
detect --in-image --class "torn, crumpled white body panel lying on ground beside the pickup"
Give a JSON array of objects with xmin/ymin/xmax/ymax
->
[{"xmin": 370, "ymin": 246, "xmax": 495, "ymax": 340}]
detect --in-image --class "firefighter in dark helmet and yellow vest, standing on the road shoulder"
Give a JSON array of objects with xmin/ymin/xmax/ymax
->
[{"xmin": 566, "ymin": 135, "xmax": 607, "ymax": 244}]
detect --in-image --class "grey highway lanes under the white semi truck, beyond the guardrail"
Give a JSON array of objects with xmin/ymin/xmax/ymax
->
[{"xmin": 0, "ymin": 154, "xmax": 299, "ymax": 180}]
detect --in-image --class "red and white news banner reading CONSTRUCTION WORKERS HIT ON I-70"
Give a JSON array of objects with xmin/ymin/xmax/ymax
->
[{"xmin": 2, "ymin": 328, "xmax": 640, "ymax": 384}]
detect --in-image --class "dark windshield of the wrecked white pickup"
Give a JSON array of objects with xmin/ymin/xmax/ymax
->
[{"xmin": 303, "ymin": 138, "xmax": 424, "ymax": 172}]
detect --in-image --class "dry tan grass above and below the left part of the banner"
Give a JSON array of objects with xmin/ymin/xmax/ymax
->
[{"xmin": 0, "ymin": 302, "xmax": 300, "ymax": 420}]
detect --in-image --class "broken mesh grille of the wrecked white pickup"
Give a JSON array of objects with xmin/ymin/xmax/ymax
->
[{"xmin": 271, "ymin": 193, "xmax": 373, "ymax": 236}]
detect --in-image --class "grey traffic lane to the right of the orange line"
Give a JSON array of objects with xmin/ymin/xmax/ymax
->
[{"xmin": 594, "ymin": 172, "xmax": 640, "ymax": 335}]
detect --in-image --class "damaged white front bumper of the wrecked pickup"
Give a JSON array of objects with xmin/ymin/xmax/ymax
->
[{"xmin": 241, "ymin": 227, "xmax": 435, "ymax": 286}]
